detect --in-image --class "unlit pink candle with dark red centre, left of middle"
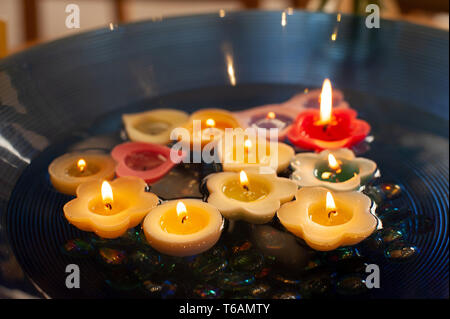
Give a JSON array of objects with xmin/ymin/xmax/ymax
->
[{"xmin": 111, "ymin": 142, "xmax": 183, "ymax": 184}]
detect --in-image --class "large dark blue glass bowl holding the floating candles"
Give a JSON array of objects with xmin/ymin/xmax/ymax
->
[{"xmin": 0, "ymin": 11, "xmax": 449, "ymax": 298}]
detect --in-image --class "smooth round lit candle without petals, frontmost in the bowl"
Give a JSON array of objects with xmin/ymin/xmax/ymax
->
[{"xmin": 142, "ymin": 199, "xmax": 223, "ymax": 256}]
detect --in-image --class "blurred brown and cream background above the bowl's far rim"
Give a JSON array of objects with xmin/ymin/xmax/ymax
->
[{"xmin": 0, "ymin": 0, "xmax": 449, "ymax": 56}]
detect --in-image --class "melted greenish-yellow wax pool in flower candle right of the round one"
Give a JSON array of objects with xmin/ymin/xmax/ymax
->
[{"xmin": 222, "ymin": 178, "xmax": 270, "ymax": 202}]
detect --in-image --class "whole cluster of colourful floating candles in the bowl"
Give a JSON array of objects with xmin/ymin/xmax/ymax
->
[{"xmin": 48, "ymin": 80, "xmax": 377, "ymax": 256}]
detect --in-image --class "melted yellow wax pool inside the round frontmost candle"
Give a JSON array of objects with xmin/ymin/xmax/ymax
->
[{"xmin": 160, "ymin": 207, "xmax": 209, "ymax": 235}]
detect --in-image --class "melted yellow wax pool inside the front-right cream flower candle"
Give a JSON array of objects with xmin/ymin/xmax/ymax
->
[{"xmin": 308, "ymin": 203, "xmax": 353, "ymax": 226}]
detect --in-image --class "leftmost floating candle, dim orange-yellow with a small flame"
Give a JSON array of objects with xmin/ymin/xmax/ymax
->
[{"xmin": 48, "ymin": 151, "xmax": 115, "ymax": 195}]
